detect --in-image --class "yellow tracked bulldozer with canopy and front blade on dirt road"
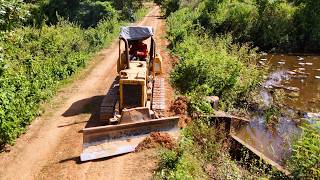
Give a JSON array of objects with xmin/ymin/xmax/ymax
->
[{"xmin": 80, "ymin": 26, "xmax": 179, "ymax": 161}]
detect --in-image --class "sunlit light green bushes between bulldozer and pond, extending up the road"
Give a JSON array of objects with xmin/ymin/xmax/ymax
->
[{"xmin": 167, "ymin": 3, "xmax": 262, "ymax": 108}]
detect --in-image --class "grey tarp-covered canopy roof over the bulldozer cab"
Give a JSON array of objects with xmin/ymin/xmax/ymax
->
[{"xmin": 120, "ymin": 26, "xmax": 154, "ymax": 41}]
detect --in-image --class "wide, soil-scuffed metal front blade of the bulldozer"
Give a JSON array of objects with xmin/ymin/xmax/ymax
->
[{"xmin": 80, "ymin": 117, "xmax": 179, "ymax": 161}]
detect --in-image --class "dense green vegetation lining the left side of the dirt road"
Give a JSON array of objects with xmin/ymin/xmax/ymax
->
[{"xmin": 0, "ymin": 0, "xmax": 147, "ymax": 146}]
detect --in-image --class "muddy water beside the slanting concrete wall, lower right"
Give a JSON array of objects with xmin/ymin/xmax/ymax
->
[{"xmin": 233, "ymin": 116, "xmax": 300, "ymax": 165}]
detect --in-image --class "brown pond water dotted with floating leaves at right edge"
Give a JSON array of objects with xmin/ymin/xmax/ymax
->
[{"xmin": 267, "ymin": 55, "xmax": 320, "ymax": 112}]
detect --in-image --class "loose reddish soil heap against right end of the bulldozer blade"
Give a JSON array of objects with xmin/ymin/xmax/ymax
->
[{"xmin": 136, "ymin": 132, "xmax": 176, "ymax": 152}]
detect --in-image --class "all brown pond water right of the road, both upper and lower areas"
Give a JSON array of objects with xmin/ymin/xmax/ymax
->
[{"xmin": 233, "ymin": 55, "xmax": 320, "ymax": 165}]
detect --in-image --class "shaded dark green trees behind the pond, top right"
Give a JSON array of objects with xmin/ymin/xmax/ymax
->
[{"xmin": 162, "ymin": 0, "xmax": 320, "ymax": 52}]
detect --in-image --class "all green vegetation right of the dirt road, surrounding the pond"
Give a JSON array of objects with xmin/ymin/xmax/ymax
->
[{"xmin": 155, "ymin": 0, "xmax": 320, "ymax": 179}]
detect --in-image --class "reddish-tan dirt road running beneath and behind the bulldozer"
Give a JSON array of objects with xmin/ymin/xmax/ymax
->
[{"xmin": 0, "ymin": 7, "xmax": 173, "ymax": 179}]
